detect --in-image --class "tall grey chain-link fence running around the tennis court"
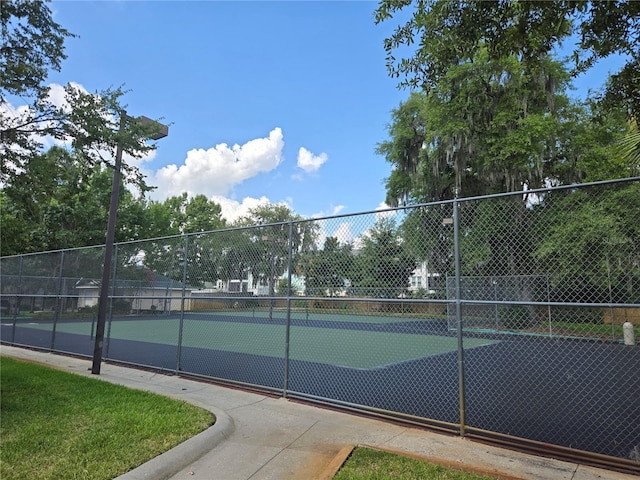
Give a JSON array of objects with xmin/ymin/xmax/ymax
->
[{"xmin": 0, "ymin": 178, "xmax": 640, "ymax": 472}]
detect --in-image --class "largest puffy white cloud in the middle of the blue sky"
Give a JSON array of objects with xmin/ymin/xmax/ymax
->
[{"xmin": 149, "ymin": 128, "xmax": 284, "ymax": 198}]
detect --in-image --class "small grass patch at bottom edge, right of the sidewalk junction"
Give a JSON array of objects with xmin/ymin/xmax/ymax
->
[{"xmin": 333, "ymin": 447, "xmax": 495, "ymax": 480}]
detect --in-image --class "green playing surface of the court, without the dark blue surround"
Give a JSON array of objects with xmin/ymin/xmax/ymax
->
[{"xmin": 16, "ymin": 317, "xmax": 495, "ymax": 369}]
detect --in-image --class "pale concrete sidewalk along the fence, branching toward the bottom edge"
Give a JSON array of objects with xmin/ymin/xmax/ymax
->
[{"xmin": 0, "ymin": 345, "xmax": 638, "ymax": 480}]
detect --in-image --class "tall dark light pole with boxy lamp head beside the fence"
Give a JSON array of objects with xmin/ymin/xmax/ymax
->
[{"xmin": 91, "ymin": 111, "xmax": 169, "ymax": 375}]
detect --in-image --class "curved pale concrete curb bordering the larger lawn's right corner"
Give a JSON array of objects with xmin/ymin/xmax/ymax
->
[{"xmin": 115, "ymin": 408, "xmax": 235, "ymax": 480}]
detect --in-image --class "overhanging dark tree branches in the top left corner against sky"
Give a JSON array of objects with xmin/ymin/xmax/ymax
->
[{"xmin": 0, "ymin": 0, "xmax": 156, "ymax": 192}]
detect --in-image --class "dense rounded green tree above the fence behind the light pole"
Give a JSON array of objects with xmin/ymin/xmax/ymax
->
[{"xmin": 0, "ymin": 147, "xmax": 167, "ymax": 255}]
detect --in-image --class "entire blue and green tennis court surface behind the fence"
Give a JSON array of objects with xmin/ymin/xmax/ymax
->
[{"xmin": 2, "ymin": 308, "xmax": 640, "ymax": 464}]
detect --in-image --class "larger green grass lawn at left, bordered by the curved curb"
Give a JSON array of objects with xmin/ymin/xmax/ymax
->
[{"xmin": 0, "ymin": 357, "xmax": 214, "ymax": 480}]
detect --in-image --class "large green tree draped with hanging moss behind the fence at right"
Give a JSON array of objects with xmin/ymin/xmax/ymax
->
[{"xmin": 378, "ymin": 50, "xmax": 633, "ymax": 296}]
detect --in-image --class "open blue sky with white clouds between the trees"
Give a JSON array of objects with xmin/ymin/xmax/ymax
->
[{"xmin": 21, "ymin": 0, "xmax": 624, "ymax": 220}]
